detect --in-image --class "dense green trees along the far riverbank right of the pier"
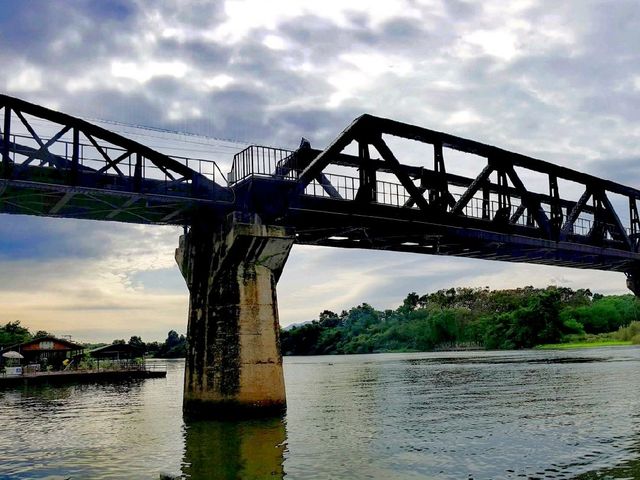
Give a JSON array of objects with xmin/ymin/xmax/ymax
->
[{"xmin": 280, "ymin": 287, "xmax": 640, "ymax": 355}]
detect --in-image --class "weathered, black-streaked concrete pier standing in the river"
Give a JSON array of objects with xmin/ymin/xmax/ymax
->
[{"xmin": 176, "ymin": 213, "xmax": 294, "ymax": 417}]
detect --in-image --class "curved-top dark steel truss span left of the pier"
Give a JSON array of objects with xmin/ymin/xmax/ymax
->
[{"xmin": 0, "ymin": 95, "xmax": 233, "ymax": 225}]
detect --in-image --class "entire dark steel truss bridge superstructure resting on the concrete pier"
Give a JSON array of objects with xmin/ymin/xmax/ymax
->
[{"xmin": 0, "ymin": 95, "xmax": 640, "ymax": 293}]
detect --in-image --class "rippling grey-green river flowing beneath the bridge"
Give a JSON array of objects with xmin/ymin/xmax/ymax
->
[{"xmin": 0, "ymin": 347, "xmax": 640, "ymax": 480}]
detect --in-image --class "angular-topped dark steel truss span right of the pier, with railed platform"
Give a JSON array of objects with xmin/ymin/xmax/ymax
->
[{"xmin": 231, "ymin": 115, "xmax": 640, "ymax": 288}]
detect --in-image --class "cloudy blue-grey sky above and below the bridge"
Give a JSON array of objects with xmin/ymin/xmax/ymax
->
[{"xmin": 0, "ymin": 0, "xmax": 640, "ymax": 341}]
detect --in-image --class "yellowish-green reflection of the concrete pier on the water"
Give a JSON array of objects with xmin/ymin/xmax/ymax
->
[{"xmin": 182, "ymin": 418, "xmax": 286, "ymax": 480}]
